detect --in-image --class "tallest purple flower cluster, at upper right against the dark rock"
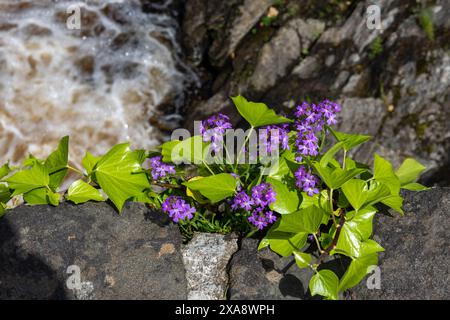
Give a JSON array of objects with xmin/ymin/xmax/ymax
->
[{"xmin": 295, "ymin": 99, "xmax": 341, "ymax": 162}]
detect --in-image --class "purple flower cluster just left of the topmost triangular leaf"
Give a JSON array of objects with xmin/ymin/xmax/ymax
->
[{"xmin": 200, "ymin": 113, "xmax": 233, "ymax": 152}]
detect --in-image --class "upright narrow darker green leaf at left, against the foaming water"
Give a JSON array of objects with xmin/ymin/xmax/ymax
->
[{"xmin": 44, "ymin": 136, "xmax": 69, "ymax": 190}]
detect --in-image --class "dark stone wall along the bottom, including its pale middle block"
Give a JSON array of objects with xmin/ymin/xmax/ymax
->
[{"xmin": 0, "ymin": 188, "xmax": 450, "ymax": 299}]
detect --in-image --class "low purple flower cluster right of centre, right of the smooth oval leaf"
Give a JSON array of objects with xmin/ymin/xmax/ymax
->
[{"xmin": 231, "ymin": 183, "xmax": 277, "ymax": 230}]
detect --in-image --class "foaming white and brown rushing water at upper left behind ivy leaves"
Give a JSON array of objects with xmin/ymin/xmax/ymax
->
[{"xmin": 0, "ymin": 0, "xmax": 190, "ymax": 163}]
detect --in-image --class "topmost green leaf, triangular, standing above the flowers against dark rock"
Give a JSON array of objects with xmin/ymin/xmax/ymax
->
[{"xmin": 231, "ymin": 96, "xmax": 292, "ymax": 128}]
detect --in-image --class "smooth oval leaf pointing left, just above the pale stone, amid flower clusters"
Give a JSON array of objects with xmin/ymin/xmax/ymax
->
[{"xmin": 183, "ymin": 173, "xmax": 237, "ymax": 203}]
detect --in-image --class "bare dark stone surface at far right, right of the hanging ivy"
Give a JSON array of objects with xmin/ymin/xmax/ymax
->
[{"xmin": 350, "ymin": 188, "xmax": 450, "ymax": 300}]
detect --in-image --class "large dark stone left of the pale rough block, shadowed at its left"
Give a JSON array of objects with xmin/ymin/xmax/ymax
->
[{"xmin": 0, "ymin": 203, "xmax": 187, "ymax": 299}]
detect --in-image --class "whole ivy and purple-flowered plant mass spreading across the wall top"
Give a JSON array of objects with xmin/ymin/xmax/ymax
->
[{"xmin": 0, "ymin": 96, "xmax": 426, "ymax": 299}]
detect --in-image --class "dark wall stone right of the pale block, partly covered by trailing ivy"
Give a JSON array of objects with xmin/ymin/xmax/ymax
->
[{"xmin": 228, "ymin": 188, "xmax": 450, "ymax": 300}]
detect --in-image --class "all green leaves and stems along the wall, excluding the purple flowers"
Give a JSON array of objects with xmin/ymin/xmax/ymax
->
[{"xmin": 0, "ymin": 96, "xmax": 426, "ymax": 299}]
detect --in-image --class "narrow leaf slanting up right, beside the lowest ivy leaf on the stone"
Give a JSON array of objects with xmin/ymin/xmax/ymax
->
[{"xmin": 339, "ymin": 253, "xmax": 378, "ymax": 291}]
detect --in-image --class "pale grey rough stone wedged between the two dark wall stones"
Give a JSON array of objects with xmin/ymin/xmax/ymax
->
[{"xmin": 182, "ymin": 233, "xmax": 238, "ymax": 300}]
